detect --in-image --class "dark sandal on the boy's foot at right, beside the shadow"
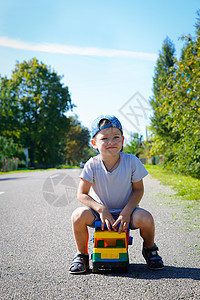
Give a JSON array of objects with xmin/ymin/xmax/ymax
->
[{"xmin": 142, "ymin": 244, "xmax": 164, "ymax": 270}]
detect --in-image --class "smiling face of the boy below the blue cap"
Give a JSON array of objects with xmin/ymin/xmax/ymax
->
[{"xmin": 91, "ymin": 127, "xmax": 124, "ymax": 155}]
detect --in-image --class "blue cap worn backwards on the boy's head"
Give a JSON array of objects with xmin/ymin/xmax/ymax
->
[{"xmin": 91, "ymin": 115, "xmax": 123, "ymax": 137}]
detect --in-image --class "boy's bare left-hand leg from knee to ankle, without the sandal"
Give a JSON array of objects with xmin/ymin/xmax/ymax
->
[{"xmin": 71, "ymin": 207, "xmax": 95, "ymax": 254}]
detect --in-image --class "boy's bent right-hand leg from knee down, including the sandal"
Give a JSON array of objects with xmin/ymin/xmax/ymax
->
[{"xmin": 132, "ymin": 209, "xmax": 164, "ymax": 270}]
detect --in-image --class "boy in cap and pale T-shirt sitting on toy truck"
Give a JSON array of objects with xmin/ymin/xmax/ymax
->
[{"xmin": 69, "ymin": 115, "xmax": 164, "ymax": 274}]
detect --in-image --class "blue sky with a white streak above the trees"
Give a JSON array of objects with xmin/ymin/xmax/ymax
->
[{"xmin": 0, "ymin": 0, "xmax": 200, "ymax": 138}]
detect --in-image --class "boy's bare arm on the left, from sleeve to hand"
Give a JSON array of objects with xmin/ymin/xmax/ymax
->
[{"xmin": 77, "ymin": 178, "xmax": 115, "ymax": 230}]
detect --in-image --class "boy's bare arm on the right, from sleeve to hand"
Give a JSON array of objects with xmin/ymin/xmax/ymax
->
[{"xmin": 113, "ymin": 180, "xmax": 144, "ymax": 233}]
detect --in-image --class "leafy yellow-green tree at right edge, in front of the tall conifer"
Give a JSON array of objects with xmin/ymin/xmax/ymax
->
[{"xmin": 159, "ymin": 23, "xmax": 200, "ymax": 178}]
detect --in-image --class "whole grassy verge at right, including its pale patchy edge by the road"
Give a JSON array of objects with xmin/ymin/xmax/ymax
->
[{"xmin": 145, "ymin": 165, "xmax": 200, "ymax": 232}]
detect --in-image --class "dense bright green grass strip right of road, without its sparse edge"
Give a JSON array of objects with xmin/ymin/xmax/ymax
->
[{"xmin": 145, "ymin": 165, "xmax": 200, "ymax": 201}]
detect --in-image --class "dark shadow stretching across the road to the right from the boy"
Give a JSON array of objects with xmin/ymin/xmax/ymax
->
[{"xmin": 99, "ymin": 264, "xmax": 200, "ymax": 280}]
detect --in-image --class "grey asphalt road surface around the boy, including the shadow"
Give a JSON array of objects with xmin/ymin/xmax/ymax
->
[{"xmin": 0, "ymin": 170, "xmax": 200, "ymax": 300}]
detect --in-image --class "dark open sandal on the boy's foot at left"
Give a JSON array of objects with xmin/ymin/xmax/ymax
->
[{"xmin": 69, "ymin": 253, "xmax": 89, "ymax": 274}]
